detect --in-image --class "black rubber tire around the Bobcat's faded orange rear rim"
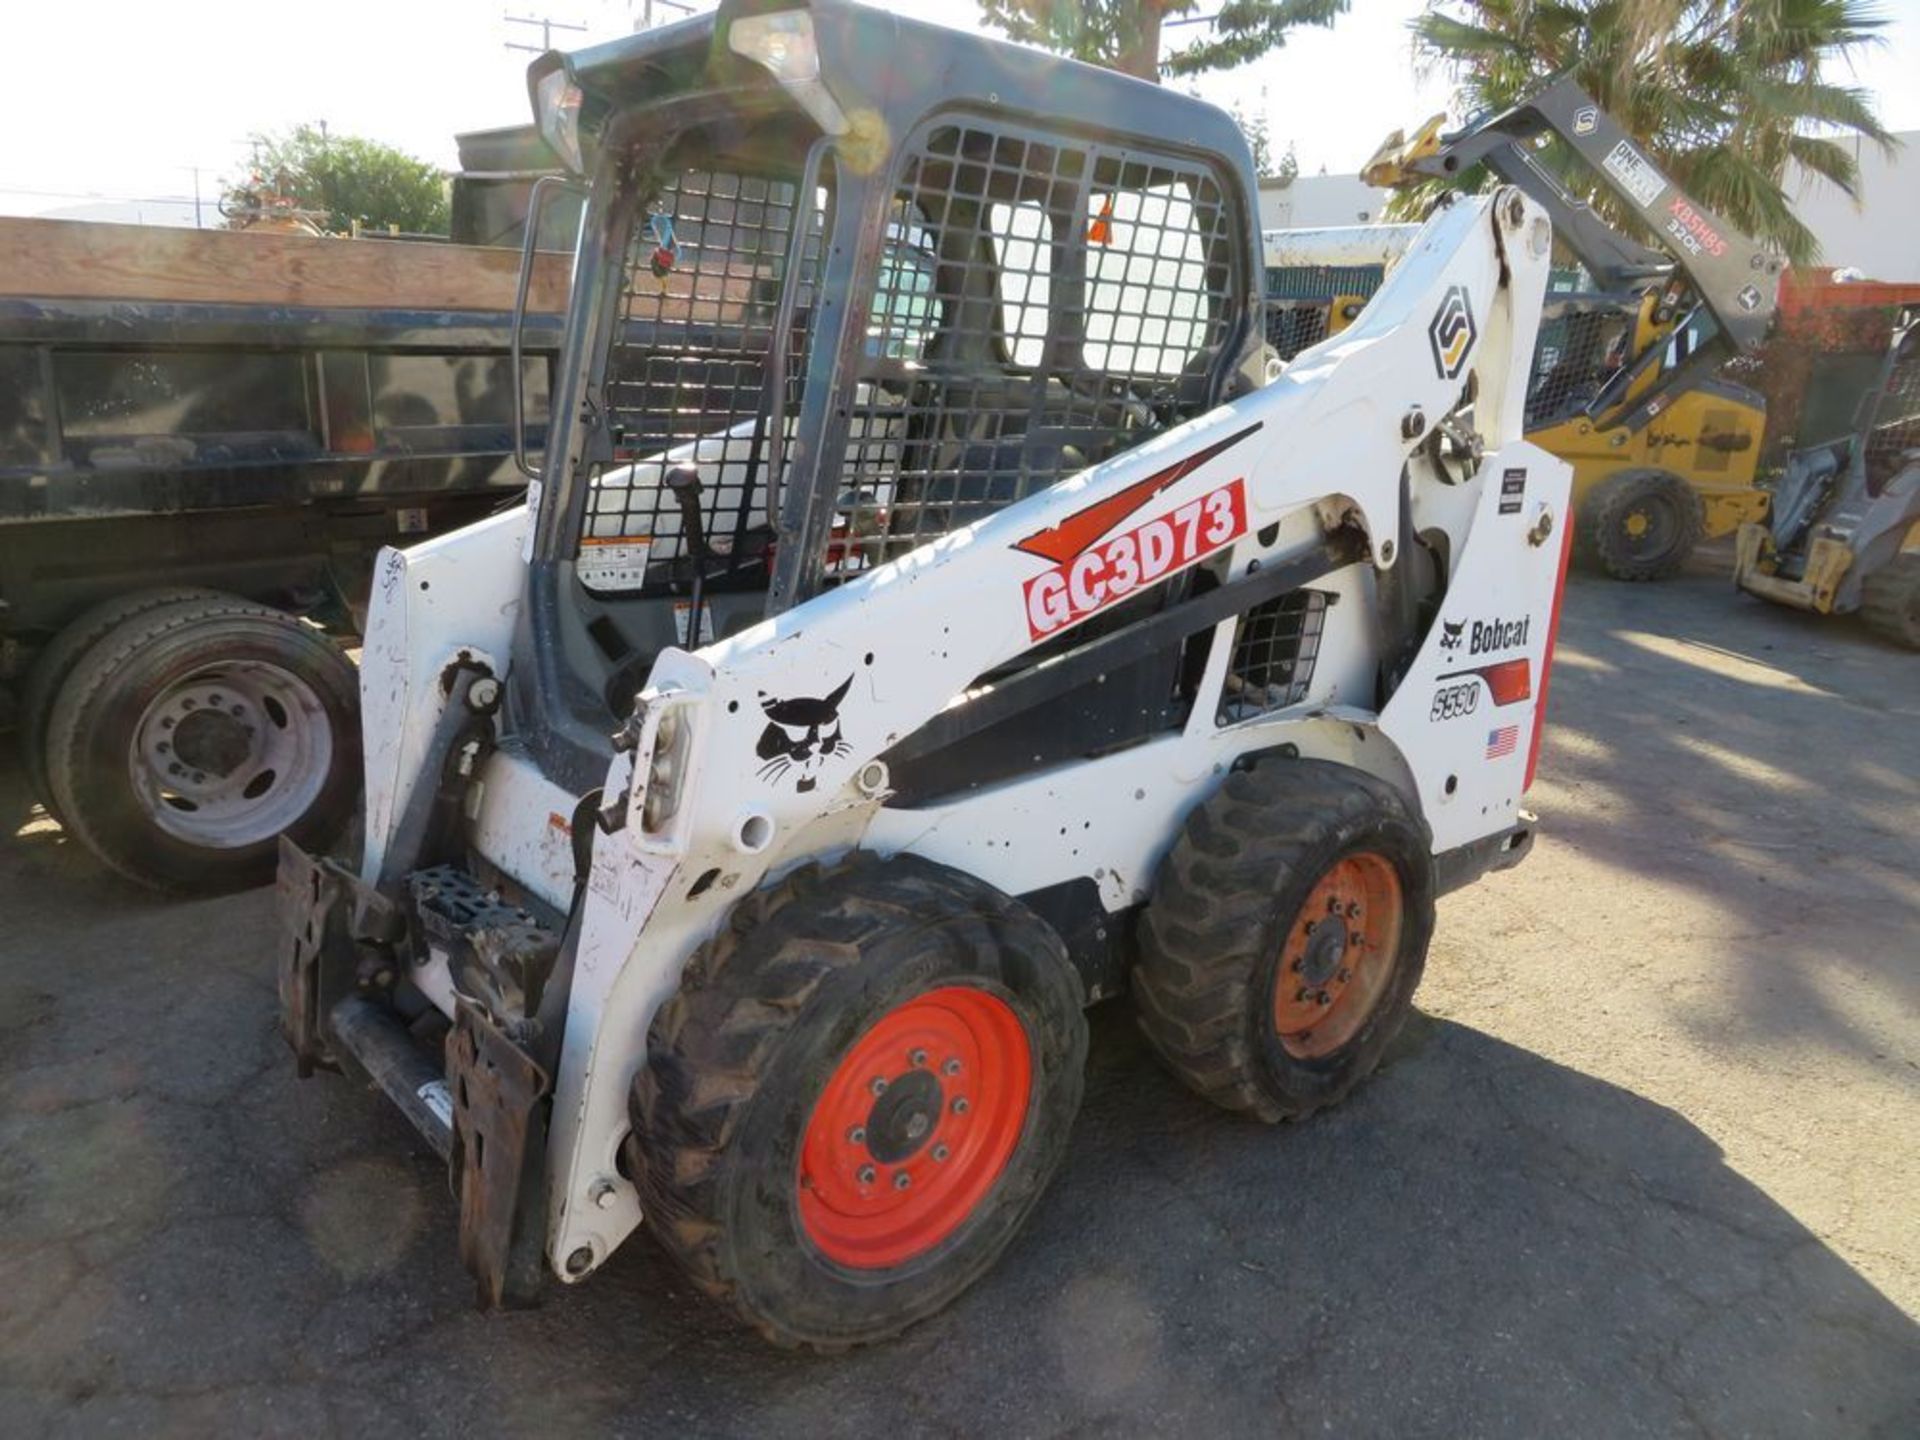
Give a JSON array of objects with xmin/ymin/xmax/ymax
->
[{"xmin": 1133, "ymin": 760, "xmax": 1434, "ymax": 1123}]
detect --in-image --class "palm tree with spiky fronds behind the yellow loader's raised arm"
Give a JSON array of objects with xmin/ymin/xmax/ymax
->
[{"xmin": 1420, "ymin": 0, "xmax": 1893, "ymax": 263}]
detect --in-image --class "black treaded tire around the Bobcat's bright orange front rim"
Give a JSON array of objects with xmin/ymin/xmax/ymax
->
[{"xmin": 632, "ymin": 854, "xmax": 1087, "ymax": 1350}]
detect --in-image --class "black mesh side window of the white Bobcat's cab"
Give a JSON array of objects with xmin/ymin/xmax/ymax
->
[{"xmin": 826, "ymin": 123, "xmax": 1240, "ymax": 580}]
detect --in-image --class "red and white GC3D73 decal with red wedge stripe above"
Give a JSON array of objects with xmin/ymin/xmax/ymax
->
[{"xmin": 1014, "ymin": 424, "xmax": 1260, "ymax": 639}]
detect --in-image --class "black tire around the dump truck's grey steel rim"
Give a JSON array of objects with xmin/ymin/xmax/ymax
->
[{"xmin": 46, "ymin": 595, "xmax": 361, "ymax": 893}]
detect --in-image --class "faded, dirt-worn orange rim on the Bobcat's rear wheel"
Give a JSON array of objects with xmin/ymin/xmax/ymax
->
[{"xmin": 1273, "ymin": 851, "xmax": 1404, "ymax": 1060}]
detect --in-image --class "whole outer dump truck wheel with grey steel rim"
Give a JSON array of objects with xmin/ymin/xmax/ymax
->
[{"xmin": 46, "ymin": 597, "xmax": 359, "ymax": 893}]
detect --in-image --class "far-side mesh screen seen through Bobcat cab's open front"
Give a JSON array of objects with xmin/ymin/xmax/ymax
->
[{"xmin": 580, "ymin": 171, "xmax": 826, "ymax": 593}]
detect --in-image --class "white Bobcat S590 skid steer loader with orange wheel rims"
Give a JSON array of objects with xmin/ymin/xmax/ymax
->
[{"xmin": 280, "ymin": 0, "xmax": 1569, "ymax": 1348}]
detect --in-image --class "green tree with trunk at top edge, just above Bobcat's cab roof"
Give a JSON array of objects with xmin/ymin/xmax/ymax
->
[{"xmin": 979, "ymin": 0, "xmax": 1350, "ymax": 81}]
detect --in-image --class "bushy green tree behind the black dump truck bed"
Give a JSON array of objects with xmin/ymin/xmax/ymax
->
[{"xmin": 223, "ymin": 125, "xmax": 449, "ymax": 234}]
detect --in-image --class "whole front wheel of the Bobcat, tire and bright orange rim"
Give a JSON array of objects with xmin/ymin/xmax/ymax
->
[{"xmin": 632, "ymin": 856, "xmax": 1087, "ymax": 1350}]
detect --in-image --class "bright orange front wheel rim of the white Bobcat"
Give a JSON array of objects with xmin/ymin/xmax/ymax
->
[{"xmin": 797, "ymin": 985, "xmax": 1033, "ymax": 1269}]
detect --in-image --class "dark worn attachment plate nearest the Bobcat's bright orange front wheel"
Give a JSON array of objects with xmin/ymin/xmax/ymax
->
[{"xmin": 447, "ymin": 998, "xmax": 553, "ymax": 1309}]
